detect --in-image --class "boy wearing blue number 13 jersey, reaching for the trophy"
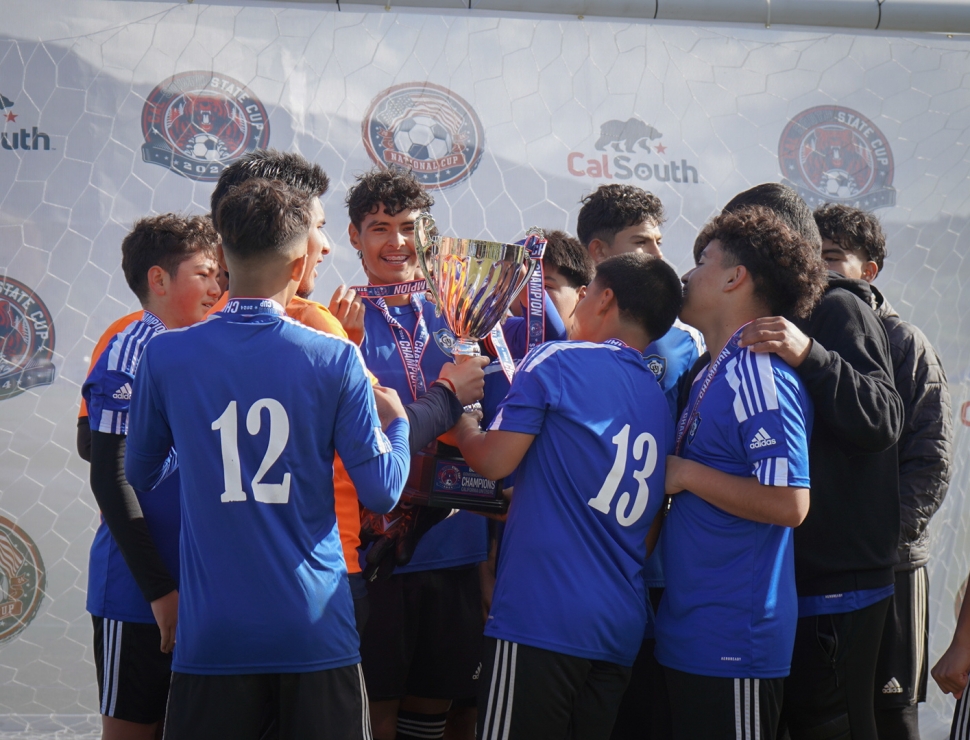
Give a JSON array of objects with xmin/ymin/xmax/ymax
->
[{"xmin": 456, "ymin": 254, "xmax": 681, "ymax": 740}]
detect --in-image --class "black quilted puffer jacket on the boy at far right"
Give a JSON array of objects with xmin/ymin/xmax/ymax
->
[{"xmin": 872, "ymin": 286, "xmax": 953, "ymax": 570}]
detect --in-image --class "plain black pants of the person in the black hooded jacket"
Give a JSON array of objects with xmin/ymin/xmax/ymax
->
[{"xmin": 782, "ymin": 597, "xmax": 890, "ymax": 740}]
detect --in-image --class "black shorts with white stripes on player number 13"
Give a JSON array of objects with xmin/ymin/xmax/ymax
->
[{"xmin": 477, "ymin": 637, "xmax": 630, "ymax": 740}]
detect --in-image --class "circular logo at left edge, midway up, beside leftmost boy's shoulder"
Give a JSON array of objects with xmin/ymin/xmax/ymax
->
[{"xmin": 0, "ymin": 276, "xmax": 54, "ymax": 400}]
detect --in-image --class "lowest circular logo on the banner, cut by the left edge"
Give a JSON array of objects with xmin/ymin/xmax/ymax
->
[{"xmin": 0, "ymin": 516, "xmax": 46, "ymax": 643}]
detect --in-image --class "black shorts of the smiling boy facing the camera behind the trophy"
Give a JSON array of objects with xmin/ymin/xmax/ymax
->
[{"xmin": 360, "ymin": 565, "xmax": 484, "ymax": 701}]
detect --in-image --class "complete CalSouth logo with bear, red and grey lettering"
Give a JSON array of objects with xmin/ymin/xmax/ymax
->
[{"xmin": 566, "ymin": 118, "xmax": 698, "ymax": 185}]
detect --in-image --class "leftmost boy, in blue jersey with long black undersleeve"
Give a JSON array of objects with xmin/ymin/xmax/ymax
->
[{"xmin": 81, "ymin": 213, "xmax": 219, "ymax": 740}]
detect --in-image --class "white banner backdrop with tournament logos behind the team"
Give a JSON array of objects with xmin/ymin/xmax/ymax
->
[{"xmin": 0, "ymin": 0, "xmax": 970, "ymax": 738}]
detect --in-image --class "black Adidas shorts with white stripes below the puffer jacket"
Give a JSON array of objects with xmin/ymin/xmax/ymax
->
[{"xmin": 875, "ymin": 566, "xmax": 930, "ymax": 709}]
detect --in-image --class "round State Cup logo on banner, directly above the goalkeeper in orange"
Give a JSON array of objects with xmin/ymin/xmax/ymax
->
[{"xmin": 141, "ymin": 72, "xmax": 269, "ymax": 182}]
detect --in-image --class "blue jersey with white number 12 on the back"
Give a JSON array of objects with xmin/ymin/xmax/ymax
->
[{"xmin": 125, "ymin": 299, "xmax": 391, "ymax": 674}]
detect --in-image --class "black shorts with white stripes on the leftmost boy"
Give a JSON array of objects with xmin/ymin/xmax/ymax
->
[{"xmin": 91, "ymin": 615, "xmax": 172, "ymax": 725}]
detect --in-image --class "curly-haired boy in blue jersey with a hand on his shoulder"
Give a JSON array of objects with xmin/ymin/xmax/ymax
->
[{"xmin": 656, "ymin": 208, "xmax": 825, "ymax": 740}]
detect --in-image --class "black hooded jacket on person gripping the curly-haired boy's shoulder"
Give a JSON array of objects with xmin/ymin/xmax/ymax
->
[{"xmin": 795, "ymin": 273, "xmax": 904, "ymax": 596}]
